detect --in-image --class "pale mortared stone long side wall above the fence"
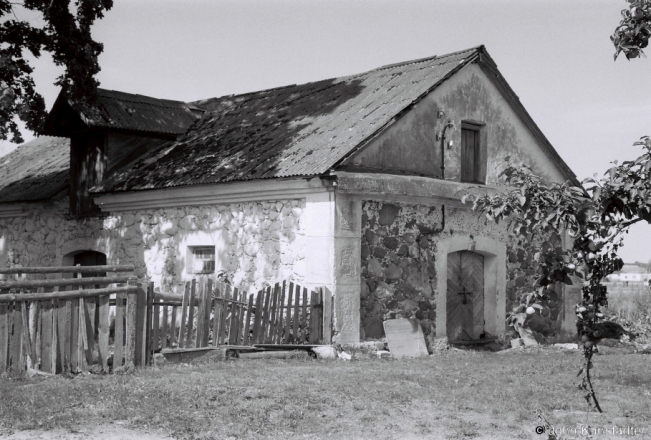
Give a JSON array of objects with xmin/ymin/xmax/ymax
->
[{"xmin": 0, "ymin": 200, "xmax": 305, "ymax": 290}]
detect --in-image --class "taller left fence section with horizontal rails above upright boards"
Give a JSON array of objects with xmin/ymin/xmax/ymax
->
[{"xmin": 0, "ymin": 265, "xmax": 153, "ymax": 373}]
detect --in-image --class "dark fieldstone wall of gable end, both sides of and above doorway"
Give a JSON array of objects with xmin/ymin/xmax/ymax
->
[{"xmin": 360, "ymin": 200, "xmax": 562, "ymax": 341}]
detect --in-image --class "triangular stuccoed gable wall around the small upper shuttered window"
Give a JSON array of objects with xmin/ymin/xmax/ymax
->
[{"xmin": 346, "ymin": 64, "xmax": 567, "ymax": 185}]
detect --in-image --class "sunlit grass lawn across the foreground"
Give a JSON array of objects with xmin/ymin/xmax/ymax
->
[{"xmin": 0, "ymin": 348, "xmax": 651, "ymax": 439}]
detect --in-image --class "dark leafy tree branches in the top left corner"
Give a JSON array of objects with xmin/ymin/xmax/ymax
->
[{"xmin": 0, "ymin": 0, "xmax": 113, "ymax": 143}]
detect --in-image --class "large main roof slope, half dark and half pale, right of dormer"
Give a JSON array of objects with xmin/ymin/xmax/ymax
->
[{"xmin": 93, "ymin": 47, "xmax": 483, "ymax": 192}]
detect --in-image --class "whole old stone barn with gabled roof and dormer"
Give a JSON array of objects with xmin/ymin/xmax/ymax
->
[{"xmin": 0, "ymin": 46, "xmax": 576, "ymax": 343}]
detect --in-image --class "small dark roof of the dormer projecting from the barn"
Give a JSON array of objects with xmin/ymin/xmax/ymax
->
[{"xmin": 62, "ymin": 89, "xmax": 203, "ymax": 134}]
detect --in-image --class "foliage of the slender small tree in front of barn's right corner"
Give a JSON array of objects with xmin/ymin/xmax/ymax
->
[{"xmin": 474, "ymin": 136, "xmax": 651, "ymax": 305}]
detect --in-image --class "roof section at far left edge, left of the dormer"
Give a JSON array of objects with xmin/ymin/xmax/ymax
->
[{"xmin": 0, "ymin": 136, "xmax": 70, "ymax": 203}]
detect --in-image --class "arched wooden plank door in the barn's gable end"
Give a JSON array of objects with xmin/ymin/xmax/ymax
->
[{"xmin": 446, "ymin": 251, "xmax": 484, "ymax": 341}]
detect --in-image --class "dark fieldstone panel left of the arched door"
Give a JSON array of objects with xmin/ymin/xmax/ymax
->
[{"xmin": 360, "ymin": 201, "xmax": 441, "ymax": 339}]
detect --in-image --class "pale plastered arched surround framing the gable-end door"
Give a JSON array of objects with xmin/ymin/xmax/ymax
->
[{"xmin": 436, "ymin": 235, "xmax": 506, "ymax": 337}]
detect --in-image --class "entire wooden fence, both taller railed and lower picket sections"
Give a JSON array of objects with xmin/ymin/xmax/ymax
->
[{"xmin": 0, "ymin": 265, "xmax": 332, "ymax": 374}]
